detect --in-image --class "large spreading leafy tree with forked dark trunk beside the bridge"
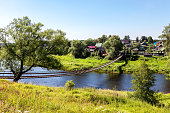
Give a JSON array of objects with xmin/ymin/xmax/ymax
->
[{"xmin": 0, "ymin": 17, "xmax": 67, "ymax": 82}]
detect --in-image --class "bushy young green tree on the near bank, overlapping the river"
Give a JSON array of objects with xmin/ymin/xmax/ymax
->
[{"xmin": 132, "ymin": 62, "xmax": 158, "ymax": 105}]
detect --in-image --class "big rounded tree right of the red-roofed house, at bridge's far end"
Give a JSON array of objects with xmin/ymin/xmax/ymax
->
[{"xmin": 103, "ymin": 35, "xmax": 123, "ymax": 59}]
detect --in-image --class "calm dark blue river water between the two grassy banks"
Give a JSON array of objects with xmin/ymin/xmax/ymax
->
[{"xmin": 0, "ymin": 67, "xmax": 170, "ymax": 93}]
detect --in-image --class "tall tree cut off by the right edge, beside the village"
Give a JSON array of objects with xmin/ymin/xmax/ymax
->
[{"xmin": 161, "ymin": 24, "xmax": 170, "ymax": 55}]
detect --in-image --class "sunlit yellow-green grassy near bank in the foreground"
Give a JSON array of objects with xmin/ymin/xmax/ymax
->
[{"xmin": 0, "ymin": 80, "xmax": 170, "ymax": 113}]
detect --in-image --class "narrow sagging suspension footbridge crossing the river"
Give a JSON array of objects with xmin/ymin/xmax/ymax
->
[{"xmin": 0, "ymin": 55, "xmax": 123, "ymax": 79}]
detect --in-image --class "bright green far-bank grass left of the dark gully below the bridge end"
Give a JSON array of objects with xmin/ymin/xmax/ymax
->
[{"xmin": 54, "ymin": 55, "xmax": 125, "ymax": 72}]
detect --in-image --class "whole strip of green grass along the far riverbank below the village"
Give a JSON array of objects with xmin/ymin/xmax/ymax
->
[{"xmin": 54, "ymin": 55, "xmax": 170, "ymax": 75}]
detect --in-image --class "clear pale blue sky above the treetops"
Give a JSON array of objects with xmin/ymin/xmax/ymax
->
[{"xmin": 0, "ymin": 0, "xmax": 170, "ymax": 40}]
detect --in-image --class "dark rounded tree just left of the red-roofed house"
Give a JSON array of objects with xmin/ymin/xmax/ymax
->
[{"xmin": 69, "ymin": 40, "xmax": 90, "ymax": 58}]
